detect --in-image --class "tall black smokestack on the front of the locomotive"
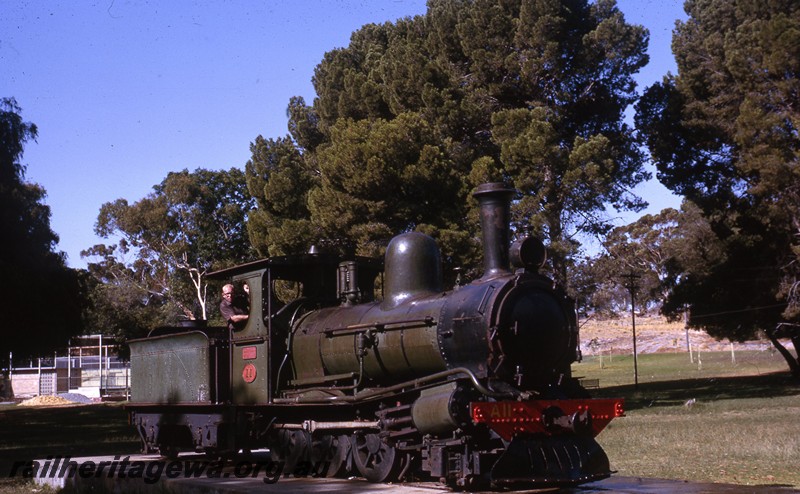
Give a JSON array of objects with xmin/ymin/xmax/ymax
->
[{"xmin": 473, "ymin": 182, "xmax": 516, "ymax": 279}]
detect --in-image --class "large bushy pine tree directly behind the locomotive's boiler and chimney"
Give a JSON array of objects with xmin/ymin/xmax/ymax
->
[{"xmin": 252, "ymin": 0, "xmax": 647, "ymax": 288}]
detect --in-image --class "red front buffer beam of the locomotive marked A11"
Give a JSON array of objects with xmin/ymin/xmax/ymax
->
[{"xmin": 470, "ymin": 398, "xmax": 625, "ymax": 440}]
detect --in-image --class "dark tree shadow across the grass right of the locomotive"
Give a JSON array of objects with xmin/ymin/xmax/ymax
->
[{"xmin": 593, "ymin": 372, "xmax": 800, "ymax": 410}]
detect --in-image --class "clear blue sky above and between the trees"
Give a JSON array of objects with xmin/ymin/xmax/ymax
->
[{"xmin": 0, "ymin": 0, "xmax": 685, "ymax": 267}]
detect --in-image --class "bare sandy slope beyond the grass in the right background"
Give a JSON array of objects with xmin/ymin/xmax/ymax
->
[{"xmin": 578, "ymin": 316, "xmax": 792, "ymax": 355}]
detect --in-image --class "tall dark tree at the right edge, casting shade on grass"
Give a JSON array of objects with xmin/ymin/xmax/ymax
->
[{"xmin": 636, "ymin": 0, "xmax": 800, "ymax": 375}]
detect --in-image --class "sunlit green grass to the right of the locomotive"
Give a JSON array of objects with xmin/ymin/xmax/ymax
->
[{"xmin": 573, "ymin": 352, "xmax": 800, "ymax": 487}]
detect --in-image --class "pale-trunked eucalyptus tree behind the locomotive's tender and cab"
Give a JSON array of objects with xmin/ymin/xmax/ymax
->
[{"xmin": 84, "ymin": 168, "xmax": 254, "ymax": 323}]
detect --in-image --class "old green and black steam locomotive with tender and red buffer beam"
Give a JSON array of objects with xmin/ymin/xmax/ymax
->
[{"xmin": 128, "ymin": 183, "xmax": 624, "ymax": 489}]
